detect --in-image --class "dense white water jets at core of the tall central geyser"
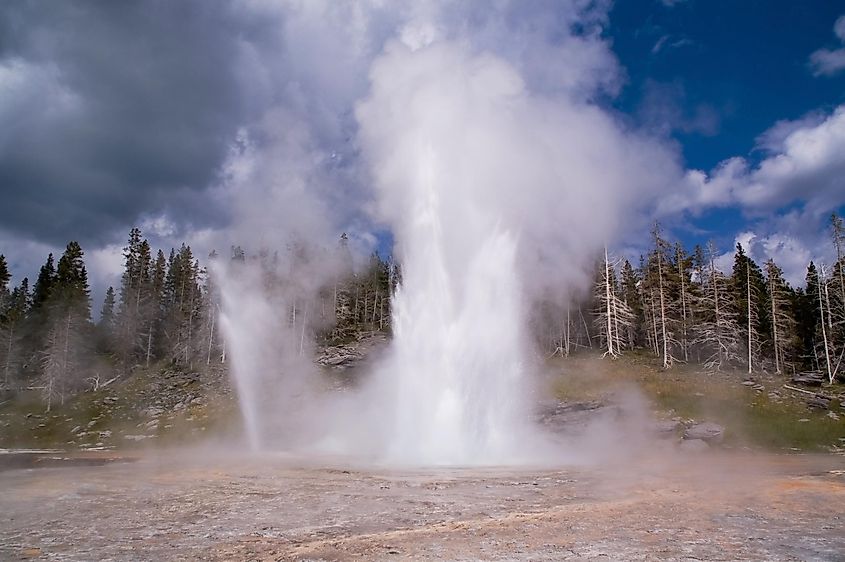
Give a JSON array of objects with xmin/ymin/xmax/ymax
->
[{"xmin": 382, "ymin": 155, "xmax": 527, "ymax": 464}]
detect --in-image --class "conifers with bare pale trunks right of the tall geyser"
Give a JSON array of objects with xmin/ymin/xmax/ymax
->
[{"xmin": 546, "ymin": 214, "xmax": 845, "ymax": 382}]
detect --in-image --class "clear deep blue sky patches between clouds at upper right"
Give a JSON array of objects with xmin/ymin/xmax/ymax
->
[{"xmin": 606, "ymin": 0, "xmax": 845, "ymax": 279}]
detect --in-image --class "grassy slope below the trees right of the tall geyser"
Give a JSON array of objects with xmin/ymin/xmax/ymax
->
[{"xmin": 552, "ymin": 353, "xmax": 845, "ymax": 451}]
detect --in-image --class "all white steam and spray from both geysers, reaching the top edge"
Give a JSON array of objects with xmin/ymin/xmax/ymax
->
[{"xmin": 214, "ymin": 2, "xmax": 680, "ymax": 464}]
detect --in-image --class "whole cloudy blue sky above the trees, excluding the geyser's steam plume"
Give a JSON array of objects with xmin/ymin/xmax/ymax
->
[{"xmin": 0, "ymin": 0, "xmax": 845, "ymax": 298}]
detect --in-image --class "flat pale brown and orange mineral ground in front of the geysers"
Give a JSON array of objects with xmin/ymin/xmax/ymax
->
[{"xmin": 0, "ymin": 454, "xmax": 845, "ymax": 560}]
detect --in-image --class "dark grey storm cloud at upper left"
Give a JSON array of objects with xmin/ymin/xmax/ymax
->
[{"xmin": 0, "ymin": 2, "xmax": 249, "ymax": 244}]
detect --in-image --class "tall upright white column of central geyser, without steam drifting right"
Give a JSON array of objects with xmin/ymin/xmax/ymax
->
[{"xmin": 357, "ymin": 37, "xmax": 540, "ymax": 465}]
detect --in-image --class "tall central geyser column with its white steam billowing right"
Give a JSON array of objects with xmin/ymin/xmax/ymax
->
[{"xmin": 356, "ymin": 33, "xmax": 672, "ymax": 464}]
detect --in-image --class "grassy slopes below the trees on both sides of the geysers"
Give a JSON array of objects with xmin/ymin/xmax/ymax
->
[{"xmin": 0, "ymin": 353, "xmax": 845, "ymax": 450}]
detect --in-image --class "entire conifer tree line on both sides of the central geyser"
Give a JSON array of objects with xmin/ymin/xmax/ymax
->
[{"xmin": 0, "ymin": 215, "xmax": 845, "ymax": 409}]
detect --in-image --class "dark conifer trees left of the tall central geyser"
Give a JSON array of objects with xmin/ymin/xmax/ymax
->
[{"xmin": 0, "ymin": 228, "xmax": 398, "ymax": 411}]
